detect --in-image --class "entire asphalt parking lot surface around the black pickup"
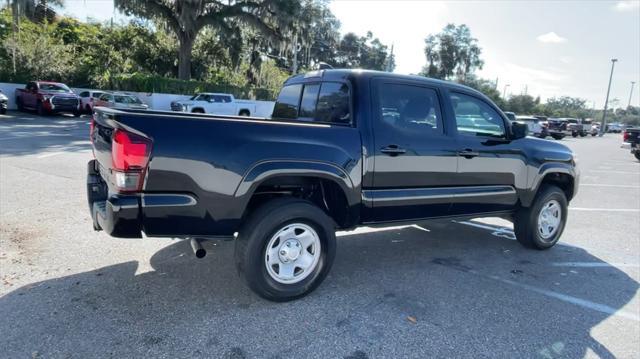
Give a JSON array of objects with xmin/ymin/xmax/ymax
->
[{"xmin": 0, "ymin": 112, "xmax": 640, "ymax": 358}]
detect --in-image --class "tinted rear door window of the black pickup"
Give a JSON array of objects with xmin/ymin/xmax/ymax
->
[{"xmin": 378, "ymin": 83, "xmax": 442, "ymax": 136}]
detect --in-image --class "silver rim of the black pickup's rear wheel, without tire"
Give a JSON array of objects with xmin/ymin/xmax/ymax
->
[{"xmin": 264, "ymin": 223, "xmax": 322, "ymax": 284}]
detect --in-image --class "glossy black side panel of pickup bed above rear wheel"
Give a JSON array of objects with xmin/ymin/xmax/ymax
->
[{"xmin": 109, "ymin": 114, "xmax": 362, "ymax": 236}]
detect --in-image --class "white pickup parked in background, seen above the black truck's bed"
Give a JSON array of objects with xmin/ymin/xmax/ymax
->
[{"xmin": 171, "ymin": 92, "xmax": 256, "ymax": 116}]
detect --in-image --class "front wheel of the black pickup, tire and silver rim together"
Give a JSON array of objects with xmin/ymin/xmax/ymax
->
[{"xmin": 513, "ymin": 185, "xmax": 567, "ymax": 250}]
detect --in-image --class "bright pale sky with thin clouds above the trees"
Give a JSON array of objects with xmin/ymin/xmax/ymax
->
[{"xmin": 63, "ymin": 0, "xmax": 640, "ymax": 108}]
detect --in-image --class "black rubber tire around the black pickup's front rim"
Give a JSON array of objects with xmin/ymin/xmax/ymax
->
[{"xmin": 513, "ymin": 185, "xmax": 568, "ymax": 250}]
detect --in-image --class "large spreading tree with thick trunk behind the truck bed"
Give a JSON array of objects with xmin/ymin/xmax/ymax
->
[{"xmin": 115, "ymin": 0, "xmax": 299, "ymax": 80}]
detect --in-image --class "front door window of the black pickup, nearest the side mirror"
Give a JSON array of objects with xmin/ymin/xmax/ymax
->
[{"xmin": 451, "ymin": 93, "xmax": 505, "ymax": 137}]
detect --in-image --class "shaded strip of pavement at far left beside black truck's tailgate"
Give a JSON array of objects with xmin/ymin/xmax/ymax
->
[{"xmin": 0, "ymin": 112, "xmax": 91, "ymax": 156}]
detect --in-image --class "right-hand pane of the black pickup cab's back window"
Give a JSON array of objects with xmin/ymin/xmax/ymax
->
[{"xmin": 316, "ymin": 82, "xmax": 351, "ymax": 123}]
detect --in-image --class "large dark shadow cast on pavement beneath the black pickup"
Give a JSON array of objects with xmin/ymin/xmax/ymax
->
[{"xmin": 0, "ymin": 223, "xmax": 638, "ymax": 358}]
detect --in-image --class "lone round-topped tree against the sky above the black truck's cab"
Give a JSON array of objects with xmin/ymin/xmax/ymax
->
[{"xmin": 421, "ymin": 24, "xmax": 484, "ymax": 82}]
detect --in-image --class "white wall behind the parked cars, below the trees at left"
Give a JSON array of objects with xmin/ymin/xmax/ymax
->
[{"xmin": 0, "ymin": 82, "xmax": 275, "ymax": 117}]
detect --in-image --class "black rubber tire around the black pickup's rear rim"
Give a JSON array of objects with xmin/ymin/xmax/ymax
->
[{"xmin": 235, "ymin": 198, "xmax": 336, "ymax": 302}]
